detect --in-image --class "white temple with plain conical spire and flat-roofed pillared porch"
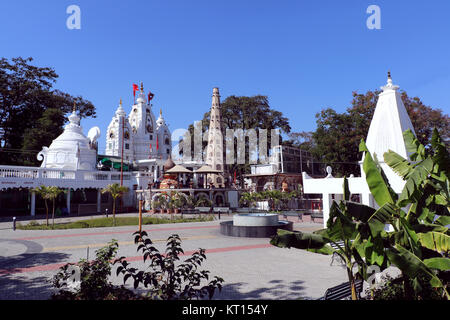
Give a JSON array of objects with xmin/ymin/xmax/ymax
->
[{"xmin": 303, "ymin": 73, "xmax": 414, "ymax": 227}]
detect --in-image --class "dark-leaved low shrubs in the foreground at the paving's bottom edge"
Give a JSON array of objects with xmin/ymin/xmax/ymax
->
[{"xmin": 51, "ymin": 231, "xmax": 223, "ymax": 300}]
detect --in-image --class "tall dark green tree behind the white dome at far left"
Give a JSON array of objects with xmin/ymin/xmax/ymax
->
[{"xmin": 0, "ymin": 57, "xmax": 95, "ymax": 165}]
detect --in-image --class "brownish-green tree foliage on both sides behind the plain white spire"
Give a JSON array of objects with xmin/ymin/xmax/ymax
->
[{"xmin": 290, "ymin": 91, "xmax": 450, "ymax": 176}]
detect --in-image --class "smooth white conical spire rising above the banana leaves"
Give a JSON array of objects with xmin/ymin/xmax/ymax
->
[{"xmin": 366, "ymin": 73, "xmax": 414, "ymax": 161}]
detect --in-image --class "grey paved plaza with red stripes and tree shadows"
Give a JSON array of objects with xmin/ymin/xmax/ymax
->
[{"xmin": 0, "ymin": 215, "xmax": 346, "ymax": 299}]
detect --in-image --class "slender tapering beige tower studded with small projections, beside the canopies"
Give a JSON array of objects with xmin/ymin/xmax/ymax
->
[{"xmin": 206, "ymin": 88, "xmax": 225, "ymax": 188}]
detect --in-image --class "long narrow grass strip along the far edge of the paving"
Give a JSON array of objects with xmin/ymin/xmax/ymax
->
[{"xmin": 17, "ymin": 216, "xmax": 213, "ymax": 230}]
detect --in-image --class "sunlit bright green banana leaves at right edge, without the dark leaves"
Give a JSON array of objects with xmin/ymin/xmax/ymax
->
[{"xmin": 358, "ymin": 130, "xmax": 450, "ymax": 299}]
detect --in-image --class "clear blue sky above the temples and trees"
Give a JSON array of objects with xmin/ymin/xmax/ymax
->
[{"xmin": 0, "ymin": 0, "xmax": 450, "ymax": 152}]
